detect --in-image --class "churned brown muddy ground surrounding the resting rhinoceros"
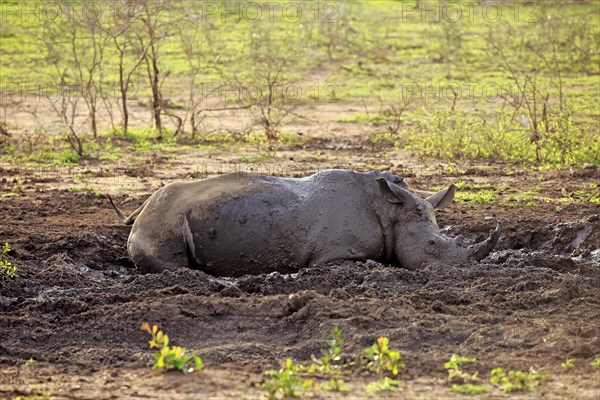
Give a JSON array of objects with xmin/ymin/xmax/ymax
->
[{"xmin": 0, "ymin": 142, "xmax": 600, "ymax": 399}]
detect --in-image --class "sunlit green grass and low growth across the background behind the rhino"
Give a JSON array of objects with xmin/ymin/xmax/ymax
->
[{"xmin": 0, "ymin": 0, "xmax": 600, "ymax": 168}]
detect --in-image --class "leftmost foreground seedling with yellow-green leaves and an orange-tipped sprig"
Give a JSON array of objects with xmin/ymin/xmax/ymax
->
[{"xmin": 141, "ymin": 322, "xmax": 203, "ymax": 372}]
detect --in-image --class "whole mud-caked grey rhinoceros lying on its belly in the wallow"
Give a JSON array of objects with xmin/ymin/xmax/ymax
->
[{"xmin": 111, "ymin": 170, "xmax": 500, "ymax": 276}]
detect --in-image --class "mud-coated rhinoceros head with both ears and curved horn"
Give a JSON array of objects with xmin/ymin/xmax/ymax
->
[{"xmin": 377, "ymin": 178, "xmax": 501, "ymax": 269}]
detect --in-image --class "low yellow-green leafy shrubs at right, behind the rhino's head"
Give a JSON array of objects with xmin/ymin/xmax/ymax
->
[{"xmin": 399, "ymin": 107, "xmax": 600, "ymax": 168}]
